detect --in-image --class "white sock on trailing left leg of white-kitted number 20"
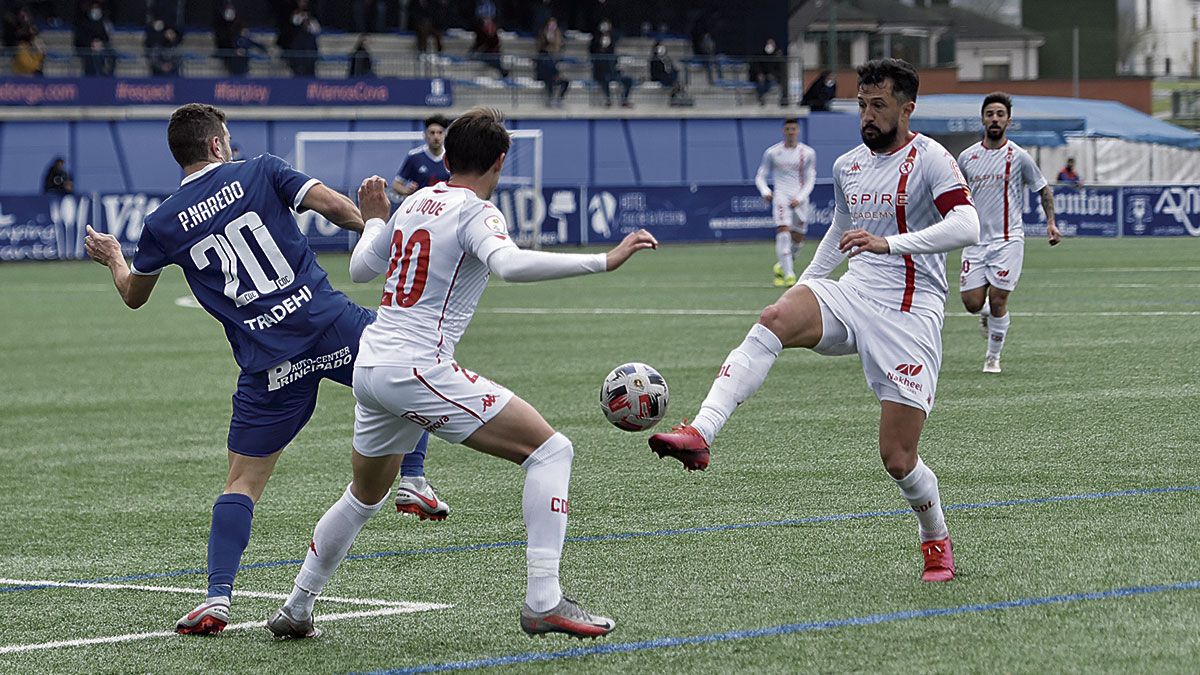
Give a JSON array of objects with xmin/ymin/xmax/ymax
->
[{"xmin": 284, "ymin": 478, "xmax": 391, "ymax": 619}]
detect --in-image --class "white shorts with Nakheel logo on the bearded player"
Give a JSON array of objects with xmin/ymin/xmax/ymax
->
[{"xmin": 800, "ymin": 279, "xmax": 942, "ymax": 416}]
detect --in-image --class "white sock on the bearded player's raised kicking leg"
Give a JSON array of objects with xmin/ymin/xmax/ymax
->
[{"xmin": 691, "ymin": 323, "xmax": 784, "ymax": 444}]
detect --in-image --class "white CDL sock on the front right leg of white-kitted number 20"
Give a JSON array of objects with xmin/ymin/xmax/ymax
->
[{"xmin": 521, "ymin": 434, "xmax": 575, "ymax": 611}]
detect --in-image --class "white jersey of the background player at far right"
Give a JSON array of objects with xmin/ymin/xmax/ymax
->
[{"xmin": 959, "ymin": 141, "xmax": 1046, "ymax": 244}]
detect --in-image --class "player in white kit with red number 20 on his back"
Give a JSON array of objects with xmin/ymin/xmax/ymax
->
[{"xmin": 268, "ymin": 108, "xmax": 658, "ymax": 638}]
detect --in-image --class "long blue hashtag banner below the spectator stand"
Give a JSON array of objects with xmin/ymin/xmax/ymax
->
[{"xmin": 0, "ymin": 77, "xmax": 454, "ymax": 108}]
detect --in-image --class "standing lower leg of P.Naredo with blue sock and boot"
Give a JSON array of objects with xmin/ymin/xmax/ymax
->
[{"xmin": 175, "ymin": 450, "xmax": 281, "ymax": 635}]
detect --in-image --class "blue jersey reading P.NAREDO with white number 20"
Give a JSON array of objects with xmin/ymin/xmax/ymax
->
[{"xmin": 132, "ymin": 155, "xmax": 353, "ymax": 372}]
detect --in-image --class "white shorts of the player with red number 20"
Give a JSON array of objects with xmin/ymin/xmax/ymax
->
[{"xmin": 354, "ymin": 362, "xmax": 512, "ymax": 456}]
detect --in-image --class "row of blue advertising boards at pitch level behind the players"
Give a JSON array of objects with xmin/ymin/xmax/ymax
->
[{"xmin": 0, "ymin": 184, "xmax": 1200, "ymax": 262}]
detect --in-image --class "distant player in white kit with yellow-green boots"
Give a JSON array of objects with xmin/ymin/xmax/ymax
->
[{"xmin": 754, "ymin": 118, "xmax": 817, "ymax": 286}]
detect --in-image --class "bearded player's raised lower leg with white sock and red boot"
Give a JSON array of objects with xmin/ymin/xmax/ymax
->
[{"xmin": 649, "ymin": 279, "xmax": 822, "ymax": 471}]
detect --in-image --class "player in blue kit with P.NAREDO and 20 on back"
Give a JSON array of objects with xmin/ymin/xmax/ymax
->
[{"xmin": 85, "ymin": 103, "xmax": 449, "ymax": 634}]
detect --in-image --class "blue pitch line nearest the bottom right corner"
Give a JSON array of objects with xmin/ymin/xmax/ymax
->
[{"xmin": 360, "ymin": 580, "xmax": 1200, "ymax": 675}]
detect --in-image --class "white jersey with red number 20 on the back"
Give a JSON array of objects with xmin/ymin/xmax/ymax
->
[{"xmin": 355, "ymin": 183, "xmax": 516, "ymax": 366}]
